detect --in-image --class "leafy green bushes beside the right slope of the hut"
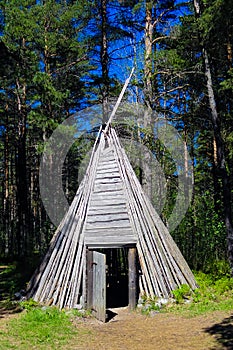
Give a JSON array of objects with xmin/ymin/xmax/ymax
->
[{"xmin": 172, "ymin": 189, "xmax": 229, "ymax": 273}]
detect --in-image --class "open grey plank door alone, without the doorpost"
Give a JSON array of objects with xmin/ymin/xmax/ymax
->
[{"xmin": 92, "ymin": 251, "xmax": 106, "ymax": 322}]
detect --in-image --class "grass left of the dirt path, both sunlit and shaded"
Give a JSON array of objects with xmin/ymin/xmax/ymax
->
[{"xmin": 0, "ymin": 262, "xmax": 93, "ymax": 350}]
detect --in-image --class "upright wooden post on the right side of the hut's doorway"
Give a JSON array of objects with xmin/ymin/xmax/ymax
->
[{"xmin": 128, "ymin": 247, "xmax": 137, "ymax": 310}]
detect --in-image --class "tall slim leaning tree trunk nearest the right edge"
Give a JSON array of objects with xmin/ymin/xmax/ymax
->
[{"xmin": 194, "ymin": 0, "xmax": 233, "ymax": 274}]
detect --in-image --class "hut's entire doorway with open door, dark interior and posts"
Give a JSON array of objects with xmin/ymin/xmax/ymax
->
[{"xmin": 86, "ymin": 245, "xmax": 139, "ymax": 320}]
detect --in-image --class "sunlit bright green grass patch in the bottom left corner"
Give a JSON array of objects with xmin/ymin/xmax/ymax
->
[{"xmin": 0, "ymin": 307, "xmax": 90, "ymax": 350}]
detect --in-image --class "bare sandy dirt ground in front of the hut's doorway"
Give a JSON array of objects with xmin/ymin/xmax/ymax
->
[{"xmin": 71, "ymin": 309, "xmax": 233, "ymax": 350}]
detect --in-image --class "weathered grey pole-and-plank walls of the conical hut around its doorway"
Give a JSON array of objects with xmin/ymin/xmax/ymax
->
[{"xmin": 28, "ymin": 125, "xmax": 197, "ymax": 308}]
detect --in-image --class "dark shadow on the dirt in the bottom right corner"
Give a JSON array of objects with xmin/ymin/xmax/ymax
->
[{"xmin": 205, "ymin": 315, "xmax": 233, "ymax": 350}]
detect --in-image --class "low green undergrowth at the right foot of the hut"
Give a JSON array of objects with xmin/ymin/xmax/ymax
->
[{"xmin": 142, "ymin": 264, "xmax": 233, "ymax": 317}]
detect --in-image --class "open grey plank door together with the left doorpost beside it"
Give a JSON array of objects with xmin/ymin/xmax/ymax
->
[{"xmin": 87, "ymin": 251, "xmax": 106, "ymax": 322}]
